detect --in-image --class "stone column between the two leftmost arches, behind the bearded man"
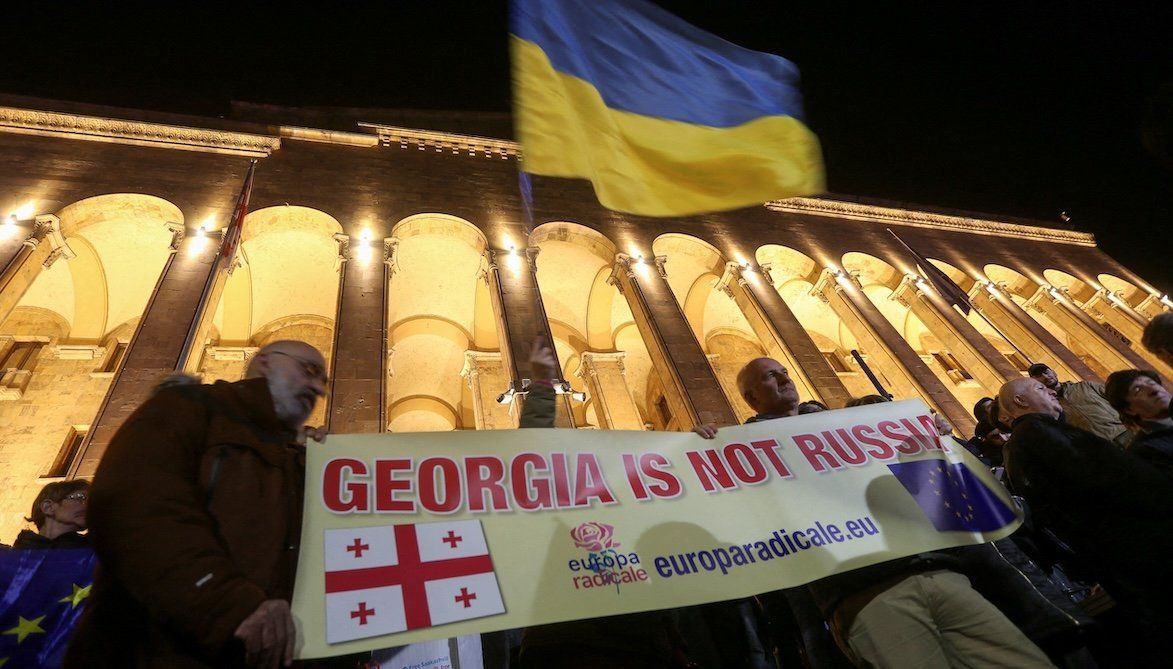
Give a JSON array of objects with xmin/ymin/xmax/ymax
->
[{"xmin": 69, "ymin": 218, "xmax": 207, "ymax": 478}]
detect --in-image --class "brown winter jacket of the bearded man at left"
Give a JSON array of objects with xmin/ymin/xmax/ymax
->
[{"xmin": 66, "ymin": 379, "xmax": 305, "ymax": 668}]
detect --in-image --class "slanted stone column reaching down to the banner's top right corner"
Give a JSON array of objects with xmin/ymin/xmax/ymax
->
[{"xmin": 812, "ymin": 270, "xmax": 977, "ymax": 434}]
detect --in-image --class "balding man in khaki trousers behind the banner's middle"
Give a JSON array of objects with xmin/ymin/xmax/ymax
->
[{"xmin": 694, "ymin": 358, "xmax": 1052, "ymax": 668}]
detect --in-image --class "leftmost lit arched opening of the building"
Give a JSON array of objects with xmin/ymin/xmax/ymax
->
[{"xmin": 0, "ymin": 194, "xmax": 183, "ymax": 536}]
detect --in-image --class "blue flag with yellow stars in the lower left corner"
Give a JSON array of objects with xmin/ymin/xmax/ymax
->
[{"xmin": 0, "ymin": 548, "xmax": 97, "ymax": 669}]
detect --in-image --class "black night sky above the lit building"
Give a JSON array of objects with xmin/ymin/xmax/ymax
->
[{"xmin": 0, "ymin": 0, "xmax": 1173, "ymax": 291}]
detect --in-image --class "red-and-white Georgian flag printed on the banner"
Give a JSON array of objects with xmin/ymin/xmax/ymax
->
[{"xmin": 325, "ymin": 520, "xmax": 506, "ymax": 643}]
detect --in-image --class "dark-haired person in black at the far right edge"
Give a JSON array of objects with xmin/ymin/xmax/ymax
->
[{"xmin": 1104, "ymin": 370, "xmax": 1173, "ymax": 466}]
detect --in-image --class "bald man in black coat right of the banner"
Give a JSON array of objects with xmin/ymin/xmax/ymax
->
[{"xmin": 998, "ymin": 379, "xmax": 1173, "ymax": 633}]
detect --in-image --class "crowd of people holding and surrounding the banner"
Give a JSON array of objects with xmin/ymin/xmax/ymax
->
[{"xmin": 4, "ymin": 313, "xmax": 1173, "ymax": 669}]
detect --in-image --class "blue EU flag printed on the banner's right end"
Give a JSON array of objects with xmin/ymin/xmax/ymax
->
[{"xmin": 888, "ymin": 459, "xmax": 1018, "ymax": 532}]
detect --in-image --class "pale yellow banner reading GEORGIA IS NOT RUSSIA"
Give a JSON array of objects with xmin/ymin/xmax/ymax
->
[{"xmin": 293, "ymin": 400, "xmax": 1018, "ymax": 657}]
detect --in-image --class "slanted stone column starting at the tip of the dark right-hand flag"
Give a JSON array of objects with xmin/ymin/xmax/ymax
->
[{"xmin": 969, "ymin": 282, "xmax": 1104, "ymax": 381}]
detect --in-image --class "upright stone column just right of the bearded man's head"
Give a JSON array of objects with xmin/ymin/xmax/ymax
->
[{"xmin": 326, "ymin": 235, "xmax": 391, "ymax": 434}]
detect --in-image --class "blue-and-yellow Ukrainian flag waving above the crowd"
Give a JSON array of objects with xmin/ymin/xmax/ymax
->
[{"xmin": 510, "ymin": 0, "xmax": 825, "ymax": 216}]
